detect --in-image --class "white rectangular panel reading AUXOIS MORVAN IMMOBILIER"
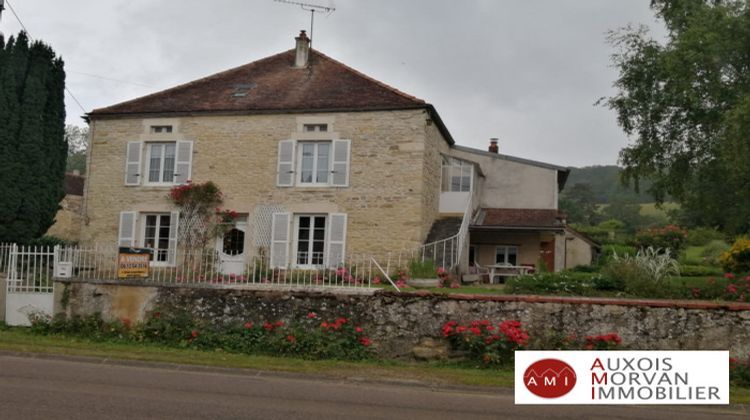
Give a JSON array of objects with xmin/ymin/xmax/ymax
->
[{"xmin": 515, "ymin": 351, "xmax": 729, "ymax": 405}]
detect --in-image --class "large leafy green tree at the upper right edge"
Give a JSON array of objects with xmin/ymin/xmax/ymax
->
[{"xmin": 605, "ymin": 0, "xmax": 750, "ymax": 233}]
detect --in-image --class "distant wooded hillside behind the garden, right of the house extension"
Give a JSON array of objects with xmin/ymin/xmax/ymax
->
[{"xmin": 562, "ymin": 165, "xmax": 654, "ymax": 204}]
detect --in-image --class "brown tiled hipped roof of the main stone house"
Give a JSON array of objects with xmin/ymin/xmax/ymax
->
[{"xmin": 89, "ymin": 49, "xmax": 431, "ymax": 117}]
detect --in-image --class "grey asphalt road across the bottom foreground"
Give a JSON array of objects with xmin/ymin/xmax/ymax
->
[{"xmin": 0, "ymin": 355, "xmax": 750, "ymax": 420}]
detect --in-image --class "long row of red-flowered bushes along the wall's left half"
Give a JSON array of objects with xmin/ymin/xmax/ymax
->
[{"xmin": 32, "ymin": 310, "xmax": 373, "ymax": 360}]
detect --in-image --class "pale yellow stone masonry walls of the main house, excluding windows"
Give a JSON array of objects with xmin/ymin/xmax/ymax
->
[{"xmin": 82, "ymin": 109, "xmax": 447, "ymax": 254}]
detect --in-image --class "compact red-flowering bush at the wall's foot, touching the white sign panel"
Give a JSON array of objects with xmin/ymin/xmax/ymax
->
[{"xmin": 442, "ymin": 319, "xmax": 529, "ymax": 366}]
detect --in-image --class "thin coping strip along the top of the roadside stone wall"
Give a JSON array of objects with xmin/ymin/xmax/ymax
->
[{"xmin": 55, "ymin": 279, "xmax": 750, "ymax": 311}]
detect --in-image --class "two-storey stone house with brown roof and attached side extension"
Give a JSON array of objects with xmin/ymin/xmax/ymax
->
[{"xmin": 81, "ymin": 31, "xmax": 600, "ymax": 278}]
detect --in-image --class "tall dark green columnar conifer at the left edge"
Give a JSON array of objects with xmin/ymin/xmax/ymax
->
[{"xmin": 0, "ymin": 32, "xmax": 68, "ymax": 242}]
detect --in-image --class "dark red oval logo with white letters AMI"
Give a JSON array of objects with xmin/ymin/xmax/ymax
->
[{"xmin": 523, "ymin": 359, "xmax": 576, "ymax": 398}]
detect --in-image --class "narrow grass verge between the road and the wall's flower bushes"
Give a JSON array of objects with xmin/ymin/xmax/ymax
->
[{"xmin": 0, "ymin": 328, "xmax": 513, "ymax": 388}]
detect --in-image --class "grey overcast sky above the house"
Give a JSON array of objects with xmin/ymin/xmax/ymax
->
[{"xmin": 0, "ymin": 0, "xmax": 660, "ymax": 166}]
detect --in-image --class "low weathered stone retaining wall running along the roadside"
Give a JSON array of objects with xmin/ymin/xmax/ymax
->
[{"xmin": 56, "ymin": 282, "xmax": 750, "ymax": 357}]
